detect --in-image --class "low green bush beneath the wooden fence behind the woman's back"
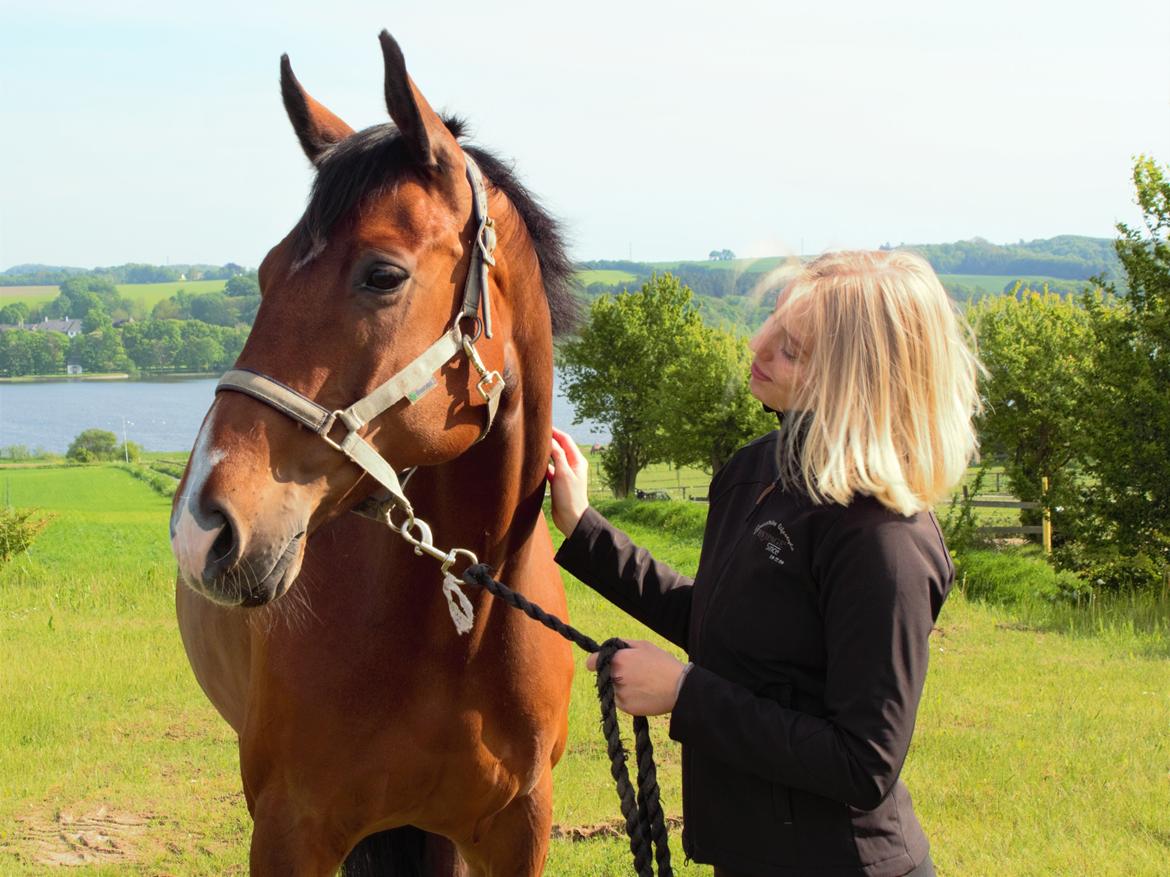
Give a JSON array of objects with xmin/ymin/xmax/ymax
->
[{"xmin": 955, "ymin": 548, "xmax": 1093, "ymax": 606}]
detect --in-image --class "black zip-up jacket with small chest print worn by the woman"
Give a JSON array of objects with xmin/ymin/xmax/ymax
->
[{"xmin": 557, "ymin": 433, "xmax": 955, "ymax": 877}]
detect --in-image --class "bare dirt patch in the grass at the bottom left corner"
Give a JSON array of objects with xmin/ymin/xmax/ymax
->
[{"xmin": 12, "ymin": 806, "xmax": 152, "ymax": 865}]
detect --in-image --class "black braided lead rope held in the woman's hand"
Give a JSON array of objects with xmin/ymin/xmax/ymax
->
[{"xmin": 463, "ymin": 564, "xmax": 674, "ymax": 877}]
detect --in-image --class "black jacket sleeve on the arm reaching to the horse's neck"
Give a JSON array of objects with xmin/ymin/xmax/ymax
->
[{"xmin": 556, "ymin": 509, "xmax": 694, "ymax": 648}]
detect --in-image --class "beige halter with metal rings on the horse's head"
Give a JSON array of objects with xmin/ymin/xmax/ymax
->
[{"xmin": 215, "ymin": 153, "xmax": 504, "ymax": 521}]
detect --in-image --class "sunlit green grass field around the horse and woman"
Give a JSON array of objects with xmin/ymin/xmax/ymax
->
[{"xmin": 0, "ymin": 467, "xmax": 1170, "ymax": 877}]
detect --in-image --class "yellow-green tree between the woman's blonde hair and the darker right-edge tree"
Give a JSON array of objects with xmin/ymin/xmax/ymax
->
[{"xmin": 968, "ymin": 284, "xmax": 1110, "ymax": 532}]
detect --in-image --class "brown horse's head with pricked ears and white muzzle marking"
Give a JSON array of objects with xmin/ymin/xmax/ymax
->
[{"xmin": 171, "ymin": 32, "xmax": 567, "ymax": 606}]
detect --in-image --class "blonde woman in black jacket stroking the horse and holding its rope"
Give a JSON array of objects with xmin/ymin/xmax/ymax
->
[{"xmin": 549, "ymin": 251, "xmax": 979, "ymax": 877}]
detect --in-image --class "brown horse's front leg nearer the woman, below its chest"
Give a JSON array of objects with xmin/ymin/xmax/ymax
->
[{"xmin": 459, "ymin": 765, "xmax": 552, "ymax": 877}]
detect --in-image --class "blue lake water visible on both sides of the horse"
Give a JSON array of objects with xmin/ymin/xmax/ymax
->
[{"xmin": 0, "ymin": 374, "xmax": 610, "ymax": 454}]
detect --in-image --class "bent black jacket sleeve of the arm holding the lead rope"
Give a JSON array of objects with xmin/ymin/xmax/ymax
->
[{"xmin": 670, "ymin": 518, "xmax": 954, "ymax": 810}]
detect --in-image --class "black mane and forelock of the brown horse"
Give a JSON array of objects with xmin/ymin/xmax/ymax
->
[{"xmin": 296, "ymin": 116, "xmax": 577, "ymax": 334}]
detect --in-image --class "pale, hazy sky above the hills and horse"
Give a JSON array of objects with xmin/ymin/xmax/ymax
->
[{"xmin": 0, "ymin": 0, "xmax": 1170, "ymax": 270}]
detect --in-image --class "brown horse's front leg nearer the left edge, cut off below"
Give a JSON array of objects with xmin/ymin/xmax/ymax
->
[{"xmin": 250, "ymin": 789, "xmax": 349, "ymax": 877}]
